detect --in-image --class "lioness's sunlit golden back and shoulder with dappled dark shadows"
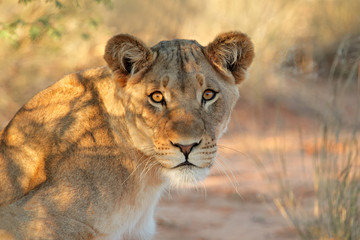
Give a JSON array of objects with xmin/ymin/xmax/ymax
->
[{"xmin": 0, "ymin": 67, "xmax": 112, "ymax": 205}]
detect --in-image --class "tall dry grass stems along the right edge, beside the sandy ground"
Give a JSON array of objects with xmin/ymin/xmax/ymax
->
[{"xmin": 274, "ymin": 37, "xmax": 360, "ymax": 240}]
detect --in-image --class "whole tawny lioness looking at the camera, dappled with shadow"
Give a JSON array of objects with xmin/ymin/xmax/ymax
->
[{"xmin": 0, "ymin": 32, "xmax": 254, "ymax": 240}]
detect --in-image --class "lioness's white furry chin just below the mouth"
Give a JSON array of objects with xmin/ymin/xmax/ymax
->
[{"xmin": 163, "ymin": 166, "xmax": 210, "ymax": 188}]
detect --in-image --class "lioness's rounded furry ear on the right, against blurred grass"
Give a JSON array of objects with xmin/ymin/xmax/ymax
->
[{"xmin": 205, "ymin": 32, "xmax": 255, "ymax": 84}]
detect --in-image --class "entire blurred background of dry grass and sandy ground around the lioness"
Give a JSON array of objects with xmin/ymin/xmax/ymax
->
[{"xmin": 0, "ymin": 0, "xmax": 360, "ymax": 239}]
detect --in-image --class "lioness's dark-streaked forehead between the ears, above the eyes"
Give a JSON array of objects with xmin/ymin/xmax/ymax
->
[{"xmin": 145, "ymin": 40, "xmax": 218, "ymax": 96}]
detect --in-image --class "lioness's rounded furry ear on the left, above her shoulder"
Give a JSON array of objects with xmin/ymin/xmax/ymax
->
[{"xmin": 104, "ymin": 34, "xmax": 153, "ymax": 87}]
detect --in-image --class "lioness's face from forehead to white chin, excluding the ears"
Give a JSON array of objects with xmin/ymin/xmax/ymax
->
[{"xmin": 105, "ymin": 31, "xmax": 253, "ymax": 184}]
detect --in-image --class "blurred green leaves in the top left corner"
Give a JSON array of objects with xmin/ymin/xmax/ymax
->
[{"xmin": 0, "ymin": 0, "xmax": 112, "ymax": 45}]
